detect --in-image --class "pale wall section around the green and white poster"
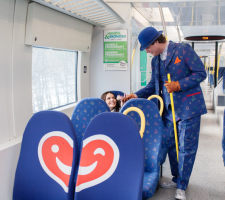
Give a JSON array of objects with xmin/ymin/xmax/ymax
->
[{"xmin": 90, "ymin": 3, "xmax": 131, "ymax": 98}]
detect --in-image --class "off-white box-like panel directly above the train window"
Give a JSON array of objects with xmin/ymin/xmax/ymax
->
[{"xmin": 25, "ymin": 3, "xmax": 93, "ymax": 52}]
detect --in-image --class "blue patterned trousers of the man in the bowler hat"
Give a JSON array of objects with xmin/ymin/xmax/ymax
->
[{"xmin": 163, "ymin": 116, "xmax": 201, "ymax": 190}]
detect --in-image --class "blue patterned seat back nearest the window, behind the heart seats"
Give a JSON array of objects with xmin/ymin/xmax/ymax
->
[{"xmin": 71, "ymin": 98, "xmax": 110, "ymax": 156}]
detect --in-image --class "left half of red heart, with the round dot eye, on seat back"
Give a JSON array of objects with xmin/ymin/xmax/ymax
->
[{"xmin": 38, "ymin": 131, "xmax": 73, "ymax": 193}]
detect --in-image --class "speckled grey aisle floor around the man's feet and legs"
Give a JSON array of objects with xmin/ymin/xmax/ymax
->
[{"xmin": 150, "ymin": 110, "xmax": 225, "ymax": 200}]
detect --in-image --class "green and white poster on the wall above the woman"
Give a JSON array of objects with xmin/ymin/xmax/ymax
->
[{"xmin": 103, "ymin": 30, "xmax": 127, "ymax": 70}]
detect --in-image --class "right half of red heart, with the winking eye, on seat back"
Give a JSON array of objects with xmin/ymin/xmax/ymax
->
[{"xmin": 76, "ymin": 135, "xmax": 119, "ymax": 192}]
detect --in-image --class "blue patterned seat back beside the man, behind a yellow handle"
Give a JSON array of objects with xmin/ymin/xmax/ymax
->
[{"xmin": 120, "ymin": 98, "xmax": 163, "ymax": 172}]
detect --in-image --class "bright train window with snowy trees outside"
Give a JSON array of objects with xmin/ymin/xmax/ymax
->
[{"xmin": 32, "ymin": 47, "xmax": 78, "ymax": 113}]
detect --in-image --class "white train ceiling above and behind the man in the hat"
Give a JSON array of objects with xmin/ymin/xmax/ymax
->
[{"xmin": 128, "ymin": 0, "xmax": 225, "ymax": 56}]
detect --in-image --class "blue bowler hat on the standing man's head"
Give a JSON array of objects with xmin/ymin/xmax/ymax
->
[{"xmin": 138, "ymin": 27, "xmax": 163, "ymax": 51}]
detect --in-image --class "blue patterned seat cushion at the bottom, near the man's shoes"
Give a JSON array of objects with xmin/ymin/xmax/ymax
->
[{"xmin": 142, "ymin": 172, "xmax": 159, "ymax": 199}]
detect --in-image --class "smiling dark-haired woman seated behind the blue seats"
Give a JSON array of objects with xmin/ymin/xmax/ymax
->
[{"xmin": 101, "ymin": 91, "xmax": 125, "ymax": 112}]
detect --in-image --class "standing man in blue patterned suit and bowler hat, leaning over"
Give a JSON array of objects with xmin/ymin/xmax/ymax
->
[{"xmin": 122, "ymin": 27, "xmax": 207, "ymax": 200}]
